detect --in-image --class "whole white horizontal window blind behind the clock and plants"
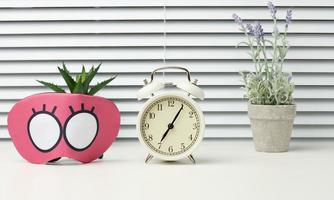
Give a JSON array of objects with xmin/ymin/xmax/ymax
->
[{"xmin": 0, "ymin": 0, "xmax": 334, "ymax": 138}]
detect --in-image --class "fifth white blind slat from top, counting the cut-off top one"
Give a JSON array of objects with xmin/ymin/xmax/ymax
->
[{"xmin": 0, "ymin": 47, "xmax": 334, "ymax": 61}]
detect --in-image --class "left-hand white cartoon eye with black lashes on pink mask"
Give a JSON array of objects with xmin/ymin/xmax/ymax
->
[{"xmin": 28, "ymin": 104, "xmax": 61, "ymax": 152}]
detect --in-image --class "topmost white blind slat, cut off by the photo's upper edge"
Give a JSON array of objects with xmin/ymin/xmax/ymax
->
[{"xmin": 0, "ymin": 0, "xmax": 334, "ymax": 8}]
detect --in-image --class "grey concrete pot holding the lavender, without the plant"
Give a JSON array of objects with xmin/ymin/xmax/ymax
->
[{"xmin": 248, "ymin": 104, "xmax": 296, "ymax": 152}]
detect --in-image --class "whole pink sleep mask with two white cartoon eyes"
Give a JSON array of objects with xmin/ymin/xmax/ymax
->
[{"xmin": 8, "ymin": 93, "xmax": 120, "ymax": 164}]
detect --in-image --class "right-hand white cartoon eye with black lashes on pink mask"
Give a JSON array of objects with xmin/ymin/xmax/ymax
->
[{"xmin": 64, "ymin": 104, "xmax": 99, "ymax": 151}]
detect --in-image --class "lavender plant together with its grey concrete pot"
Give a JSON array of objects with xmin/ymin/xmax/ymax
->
[{"xmin": 232, "ymin": 2, "xmax": 296, "ymax": 152}]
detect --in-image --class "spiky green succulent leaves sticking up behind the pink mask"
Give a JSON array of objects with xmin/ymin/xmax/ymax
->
[{"xmin": 37, "ymin": 63, "xmax": 116, "ymax": 95}]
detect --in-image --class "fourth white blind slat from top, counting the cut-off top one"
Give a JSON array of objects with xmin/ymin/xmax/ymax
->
[{"xmin": 0, "ymin": 33, "xmax": 334, "ymax": 48}]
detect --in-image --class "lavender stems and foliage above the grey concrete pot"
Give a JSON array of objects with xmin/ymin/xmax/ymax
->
[{"xmin": 232, "ymin": 2, "xmax": 294, "ymax": 105}]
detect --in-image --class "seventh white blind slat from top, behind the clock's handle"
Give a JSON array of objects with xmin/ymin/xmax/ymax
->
[{"xmin": 0, "ymin": 73, "xmax": 334, "ymax": 87}]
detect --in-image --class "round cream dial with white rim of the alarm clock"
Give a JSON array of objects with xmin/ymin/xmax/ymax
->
[{"xmin": 138, "ymin": 94, "xmax": 204, "ymax": 160}]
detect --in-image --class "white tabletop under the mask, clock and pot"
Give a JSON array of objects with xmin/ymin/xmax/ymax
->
[{"xmin": 0, "ymin": 139, "xmax": 334, "ymax": 200}]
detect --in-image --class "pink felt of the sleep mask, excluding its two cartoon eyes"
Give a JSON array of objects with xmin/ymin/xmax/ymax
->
[{"xmin": 8, "ymin": 93, "xmax": 120, "ymax": 164}]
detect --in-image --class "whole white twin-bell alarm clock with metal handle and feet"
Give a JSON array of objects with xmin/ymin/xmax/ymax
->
[{"xmin": 137, "ymin": 67, "xmax": 205, "ymax": 163}]
